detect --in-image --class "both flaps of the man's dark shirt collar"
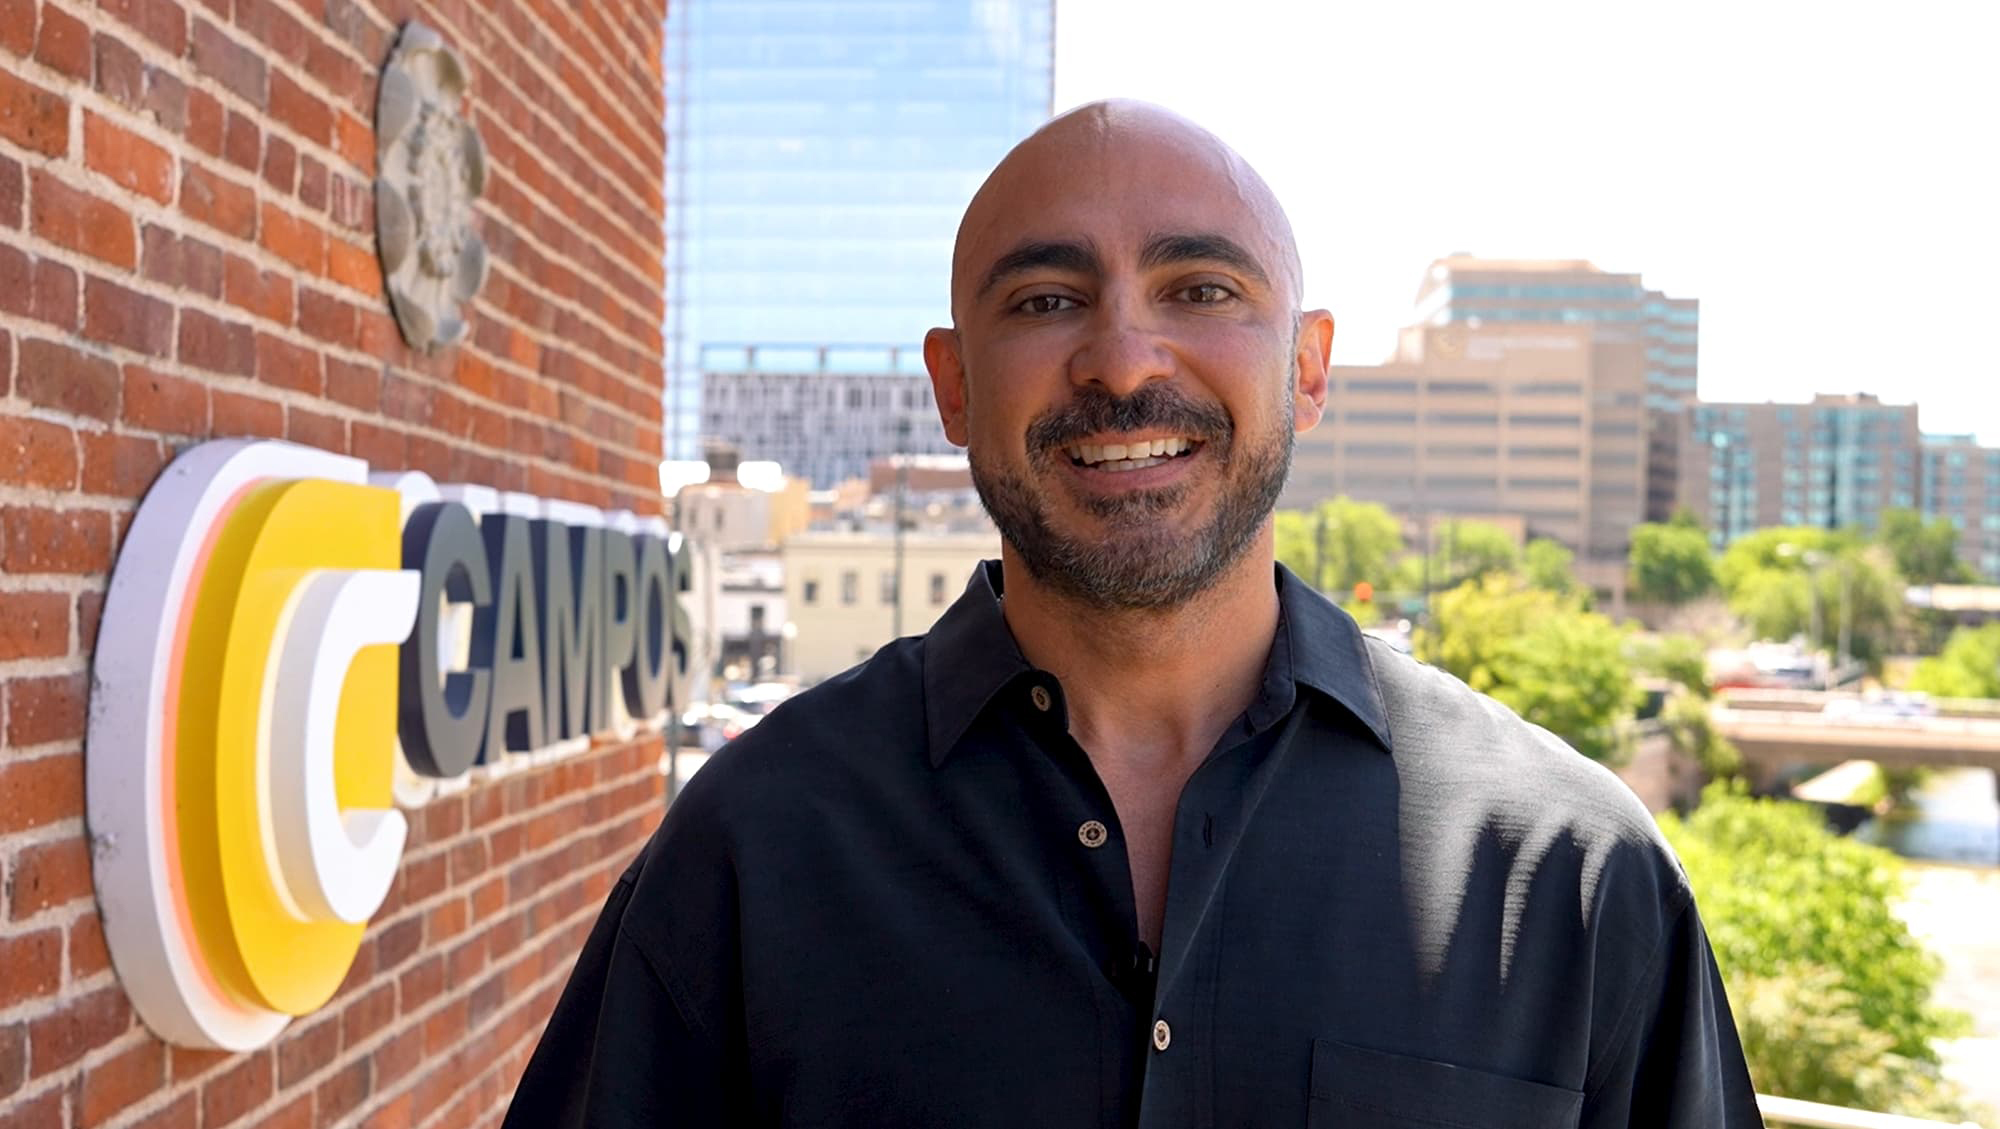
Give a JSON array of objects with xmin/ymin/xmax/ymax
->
[{"xmin": 924, "ymin": 560, "xmax": 1392, "ymax": 767}]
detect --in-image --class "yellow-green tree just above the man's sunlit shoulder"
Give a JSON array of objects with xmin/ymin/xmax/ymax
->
[{"xmin": 1414, "ymin": 573, "xmax": 1640, "ymax": 761}]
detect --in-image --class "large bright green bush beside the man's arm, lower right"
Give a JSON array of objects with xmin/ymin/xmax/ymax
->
[{"xmin": 1660, "ymin": 785, "xmax": 1966, "ymax": 1117}]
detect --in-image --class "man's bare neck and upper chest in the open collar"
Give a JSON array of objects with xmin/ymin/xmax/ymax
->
[{"xmin": 1002, "ymin": 524, "xmax": 1278, "ymax": 772}]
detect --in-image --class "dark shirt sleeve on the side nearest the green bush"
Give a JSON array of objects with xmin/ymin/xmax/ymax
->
[{"xmin": 1580, "ymin": 899, "xmax": 1764, "ymax": 1129}]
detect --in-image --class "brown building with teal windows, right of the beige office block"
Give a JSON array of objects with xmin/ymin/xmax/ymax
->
[{"xmin": 1680, "ymin": 392, "xmax": 1922, "ymax": 548}]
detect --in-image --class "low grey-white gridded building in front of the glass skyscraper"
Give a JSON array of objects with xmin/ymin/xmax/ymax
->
[{"xmin": 702, "ymin": 346, "xmax": 958, "ymax": 490}]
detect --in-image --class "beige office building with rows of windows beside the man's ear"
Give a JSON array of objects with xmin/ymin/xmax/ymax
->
[{"xmin": 1280, "ymin": 322, "xmax": 1648, "ymax": 593}]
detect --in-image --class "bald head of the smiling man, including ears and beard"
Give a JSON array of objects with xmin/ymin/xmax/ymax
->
[{"xmin": 924, "ymin": 104, "xmax": 1332, "ymax": 609}]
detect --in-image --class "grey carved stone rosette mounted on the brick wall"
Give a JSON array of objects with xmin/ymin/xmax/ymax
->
[{"xmin": 376, "ymin": 20, "xmax": 486, "ymax": 352}]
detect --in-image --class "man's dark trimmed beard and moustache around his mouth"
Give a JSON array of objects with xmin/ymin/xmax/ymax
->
[{"xmin": 970, "ymin": 380, "xmax": 1294, "ymax": 611}]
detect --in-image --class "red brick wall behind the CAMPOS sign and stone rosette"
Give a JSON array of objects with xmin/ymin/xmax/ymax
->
[{"xmin": 0, "ymin": 0, "xmax": 664, "ymax": 1129}]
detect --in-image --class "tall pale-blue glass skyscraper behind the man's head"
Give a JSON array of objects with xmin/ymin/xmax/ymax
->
[{"xmin": 666, "ymin": 0, "xmax": 1054, "ymax": 458}]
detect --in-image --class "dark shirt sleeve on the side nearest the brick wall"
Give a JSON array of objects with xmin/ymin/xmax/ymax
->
[{"xmin": 502, "ymin": 867, "xmax": 742, "ymax": 1129}]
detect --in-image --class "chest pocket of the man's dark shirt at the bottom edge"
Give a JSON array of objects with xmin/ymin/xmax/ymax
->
[{"xmin": 1306, "ymin": 1039, "xmax": 1584, "ymax": 1129}]
